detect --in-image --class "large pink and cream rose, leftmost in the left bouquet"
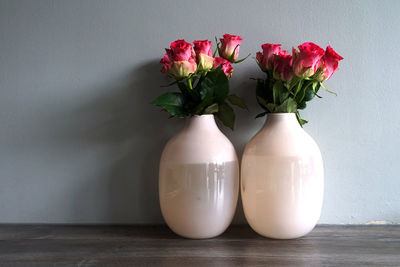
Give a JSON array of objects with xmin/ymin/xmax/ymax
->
[{"xmin": 160, "ymin": 40, "xmax": 197, "ymax": 79}]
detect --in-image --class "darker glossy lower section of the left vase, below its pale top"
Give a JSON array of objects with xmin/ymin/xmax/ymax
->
[{"xmin": 159, "ymin": 162, "xmax": 239, "ymax": 238}]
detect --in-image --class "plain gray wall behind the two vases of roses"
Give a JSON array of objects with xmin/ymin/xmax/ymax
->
[{"xmin": 0, "ymin": 0, "xmax": 400, "ymax": 224}]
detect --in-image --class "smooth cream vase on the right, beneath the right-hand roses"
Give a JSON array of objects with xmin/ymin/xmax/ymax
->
[{"xmin": 241, "ymin": 113, "xmax": 324, "ymax": 239}]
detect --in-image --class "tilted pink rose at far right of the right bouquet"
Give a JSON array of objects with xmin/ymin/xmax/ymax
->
[{"xmin": 315, "ymin": 45, "xmax": 343, "ymax": 82}]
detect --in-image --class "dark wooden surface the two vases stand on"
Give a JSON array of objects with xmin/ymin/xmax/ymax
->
[{"xmin": 0, "ymin": 225, "xmax": 400, "ymax": 267}]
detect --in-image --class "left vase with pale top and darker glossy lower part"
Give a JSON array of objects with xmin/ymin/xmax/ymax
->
[{"xmin": 159, "ymin": 115, "xmax": 239, "ymax": 239}]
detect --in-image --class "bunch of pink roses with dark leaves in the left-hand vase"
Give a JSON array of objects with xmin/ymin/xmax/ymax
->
[{"xmin": 153, "ymin": 34, "xmax": 247, "ymax": 129}]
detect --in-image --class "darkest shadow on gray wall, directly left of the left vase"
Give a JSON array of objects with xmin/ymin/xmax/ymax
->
[{"xmin": 91, "ymin": 60, "xmax": 182, "ymax": 224}]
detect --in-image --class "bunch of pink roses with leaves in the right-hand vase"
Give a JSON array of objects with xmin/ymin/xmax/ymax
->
[{"xmin": 256, "ymin": 42, "xmax": 343, "ymax": 126}]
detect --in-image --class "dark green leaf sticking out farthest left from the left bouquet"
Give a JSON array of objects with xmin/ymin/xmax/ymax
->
[{"xmin": 152, "ymin": 93, "xmax": 186, "ymax": 117}]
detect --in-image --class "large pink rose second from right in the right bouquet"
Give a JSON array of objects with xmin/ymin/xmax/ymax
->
[{"xmin": 293, "ymin": 42, "xmax": 325, "ymax": 78}]
